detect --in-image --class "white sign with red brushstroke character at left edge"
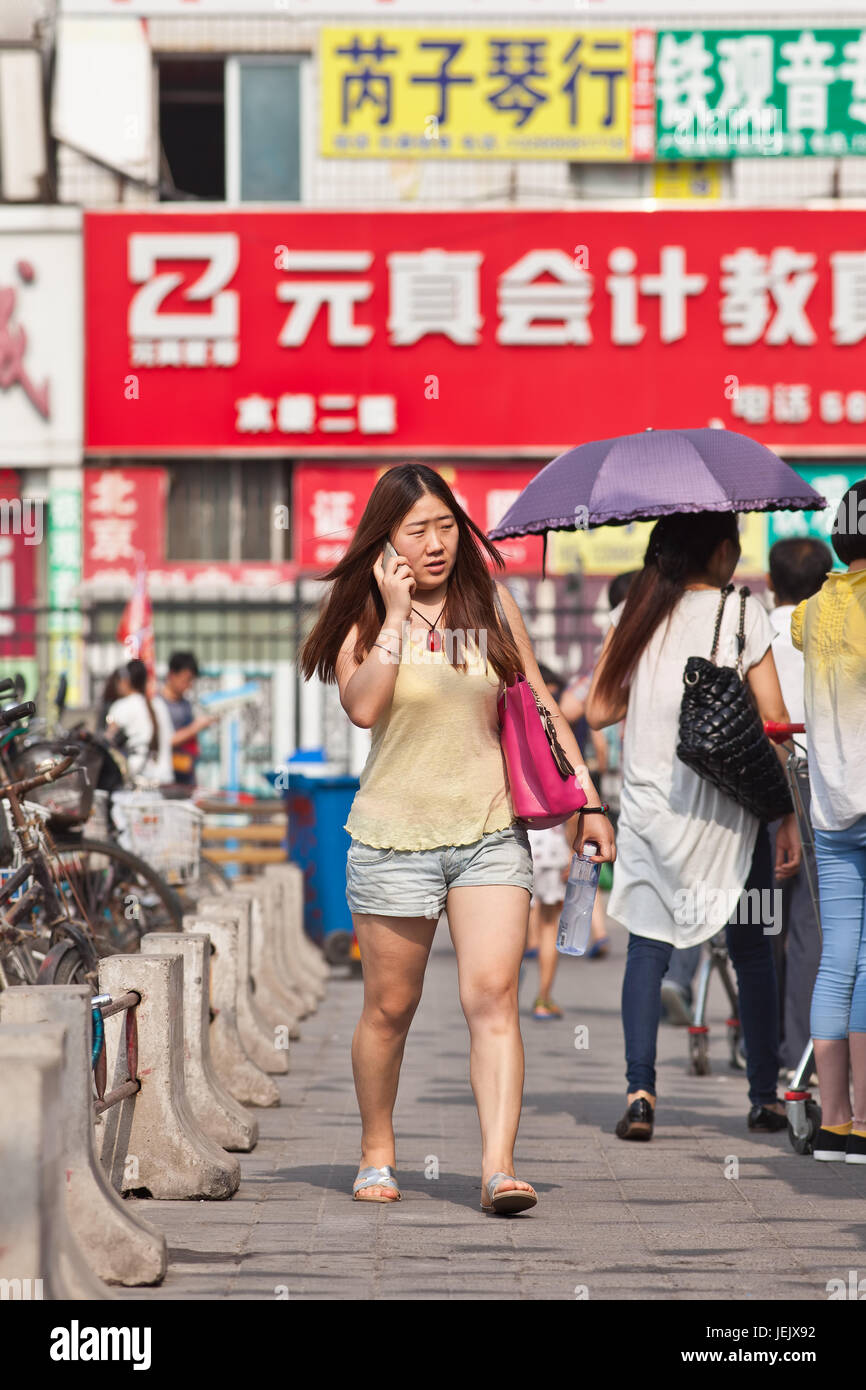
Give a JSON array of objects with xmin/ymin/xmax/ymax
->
[{"xmin": 0, "ymin": 207, "xmax": 83, "ymax": 467}]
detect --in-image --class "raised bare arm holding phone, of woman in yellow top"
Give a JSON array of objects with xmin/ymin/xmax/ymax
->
[{"xmin": 336, "ymin": 555, "xmax": 414, "ymax": 728}]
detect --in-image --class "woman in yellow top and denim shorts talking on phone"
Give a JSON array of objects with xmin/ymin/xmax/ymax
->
[{"xmin": 300, "ymin": 463, "xmax": 616, "ymax": 1212}]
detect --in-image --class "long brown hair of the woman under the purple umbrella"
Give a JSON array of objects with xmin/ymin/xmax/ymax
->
[{"xmin": 596, "ymin": 512, "xmax": 738, "ymax": 701}]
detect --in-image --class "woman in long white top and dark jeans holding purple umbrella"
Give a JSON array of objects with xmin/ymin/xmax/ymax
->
[{"xmin": 489, "ymin": 428, "xmax": 827, "ymax": 1140}]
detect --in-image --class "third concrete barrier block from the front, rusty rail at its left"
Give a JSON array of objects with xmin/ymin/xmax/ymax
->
[{"xmin": 99, "ymin": 955, "xmax": 240, "ymax": 1200}]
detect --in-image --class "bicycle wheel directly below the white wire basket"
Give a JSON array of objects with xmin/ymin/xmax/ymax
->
[{"xmin": 54, "ymin": 840, "xmax": 183, "ymax": 955}]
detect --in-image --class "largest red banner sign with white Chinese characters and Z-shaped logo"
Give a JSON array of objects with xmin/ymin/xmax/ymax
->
[{"xmin": 85, "ymin": 207, "xmax": 866, "ymax": 456}]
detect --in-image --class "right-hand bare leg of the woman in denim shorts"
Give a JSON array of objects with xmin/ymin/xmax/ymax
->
[{"xmin": 446, "ymin": 884, "xmax": 530, "ymax": 1191}]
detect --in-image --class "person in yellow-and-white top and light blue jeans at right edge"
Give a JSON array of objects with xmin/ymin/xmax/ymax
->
[{"xmin": 791, "ymin": 478, "xmax": 866, "ymax": 1163}]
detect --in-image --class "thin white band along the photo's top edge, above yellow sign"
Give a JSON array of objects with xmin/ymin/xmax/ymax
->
[{"xmin": 58, "ymin": 0, "xmax": 863, "ymax": 14}]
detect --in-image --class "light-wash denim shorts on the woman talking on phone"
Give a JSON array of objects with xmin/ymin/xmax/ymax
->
[{"xmin": 346, "ymin": 824, "xmax": 532, "ymax": 922}]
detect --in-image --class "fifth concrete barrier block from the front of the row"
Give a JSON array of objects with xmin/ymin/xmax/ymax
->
[{"xmin": 183, "ymin": 913, "xmax": 279, "ymax": 1108}]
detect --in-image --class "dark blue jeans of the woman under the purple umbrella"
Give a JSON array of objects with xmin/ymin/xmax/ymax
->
[{"xmin": 623, "ymin": 826, "xmax": 778, "ymax": 1105}]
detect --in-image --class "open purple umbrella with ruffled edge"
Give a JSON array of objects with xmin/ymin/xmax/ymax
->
[{"xmin": 489, "ymin": 430, "xmax": 827, "ymax": 541}]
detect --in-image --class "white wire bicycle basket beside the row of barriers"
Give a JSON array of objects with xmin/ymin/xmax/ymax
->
[{"xmin": 111, "ymin": 791, "xmax": 204, "ymax": 883}]
